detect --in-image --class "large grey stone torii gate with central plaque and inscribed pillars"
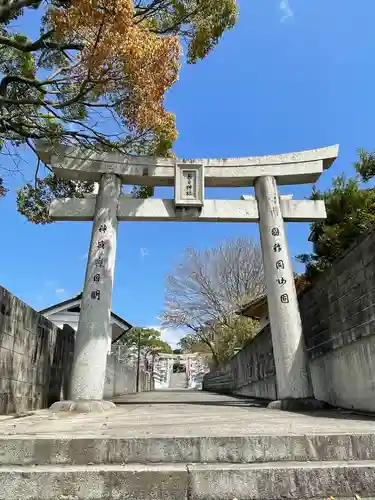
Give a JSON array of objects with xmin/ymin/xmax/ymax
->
[{"xmin": 38, "ymin": 145, "xmax": 338, "ymax": 412}]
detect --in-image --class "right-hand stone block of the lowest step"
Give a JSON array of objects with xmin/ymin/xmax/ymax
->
[{"xmin": 188, "ymin": 461, "xmax": 375, "ymax": 500}]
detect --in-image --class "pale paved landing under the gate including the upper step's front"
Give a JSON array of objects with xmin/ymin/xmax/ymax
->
[{"xmin": 0, "ymin": 390, "xmax": 375, "ymax": 465}]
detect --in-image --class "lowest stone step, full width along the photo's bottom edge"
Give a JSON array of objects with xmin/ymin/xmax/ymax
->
[{"xmin": 0, "ymin": 460, "xmax": 375, "ymax": 500}]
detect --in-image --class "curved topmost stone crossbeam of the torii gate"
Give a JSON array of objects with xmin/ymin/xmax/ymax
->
[{"xmin": 37, "ymin": 143, "xmax": 339, "ymax": 187}]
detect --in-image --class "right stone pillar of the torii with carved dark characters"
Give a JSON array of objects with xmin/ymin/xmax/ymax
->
[{"xmin": 254, "ymin": 176, "xmax": 319, "ymax": 409}]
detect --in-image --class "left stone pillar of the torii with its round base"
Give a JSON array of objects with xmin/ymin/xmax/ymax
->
[{"xmin": 51, "ymin": 174, "xmax": 122, "ymax": 413}]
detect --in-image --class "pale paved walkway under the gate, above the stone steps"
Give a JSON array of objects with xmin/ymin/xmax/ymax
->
[{"xmin": 0, "ymin": 390, "xmax": 375, "ymax": 438}]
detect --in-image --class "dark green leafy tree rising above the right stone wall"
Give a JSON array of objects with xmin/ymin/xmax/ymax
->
[{"xmin": 297, "ymin": 149, "xmax": 375, "ymax": 279}]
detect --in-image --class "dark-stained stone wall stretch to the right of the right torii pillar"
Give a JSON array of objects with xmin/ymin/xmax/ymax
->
[{"xmin": 300, "ymin": 231, "xmax": 375, "ymax": 411}]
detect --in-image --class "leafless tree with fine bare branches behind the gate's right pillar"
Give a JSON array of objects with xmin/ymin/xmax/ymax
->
[{"xmin": 162, "ymin": 238, "xmax": 265, "ymax": 364}]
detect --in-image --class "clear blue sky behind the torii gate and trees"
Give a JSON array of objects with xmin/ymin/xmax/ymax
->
[{"xmin": 0, "ymin": 0, "xmax": 375, "ymax": 341}]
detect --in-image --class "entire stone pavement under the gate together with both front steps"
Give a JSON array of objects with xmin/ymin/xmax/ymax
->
[{"xmin": 0, "ymin": 390, "xmax": 375, "ymax": 500}]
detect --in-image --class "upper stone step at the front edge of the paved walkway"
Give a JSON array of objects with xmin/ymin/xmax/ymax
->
[{"xmin": 0, "ymin": 434, "xmax": 375, "ymax": 466}]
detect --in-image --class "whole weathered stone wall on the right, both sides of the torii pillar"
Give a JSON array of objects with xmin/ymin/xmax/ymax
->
[{"xmin": 203, "ymin": 229, "xmax": 375, "ymax": 411}]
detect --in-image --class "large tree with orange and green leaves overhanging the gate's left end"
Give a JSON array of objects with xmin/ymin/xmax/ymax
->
[{"xmin": 0, "ymin": 0, "xmax": 237, "ymax": 223}]
